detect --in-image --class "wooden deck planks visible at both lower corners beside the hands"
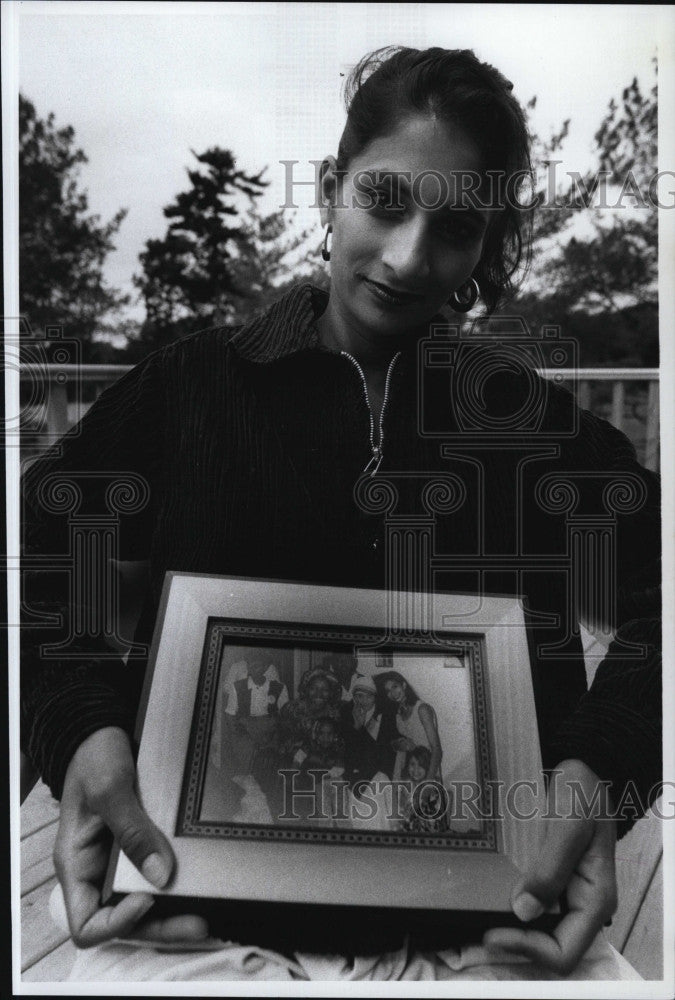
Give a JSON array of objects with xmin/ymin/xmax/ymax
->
[{"xmin": 21, "ymin": 783, "xmax": 663, "ymax": 983}]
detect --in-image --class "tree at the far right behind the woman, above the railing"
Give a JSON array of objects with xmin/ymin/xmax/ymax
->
[{"xmin": 514, "ymin": 65, "xmax": 658, "ymax": 365}]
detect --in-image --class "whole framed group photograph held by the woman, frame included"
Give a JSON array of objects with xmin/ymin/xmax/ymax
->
[{"xmin": 112, "ymin": 573, "xmax": 545, "ymax": 913}]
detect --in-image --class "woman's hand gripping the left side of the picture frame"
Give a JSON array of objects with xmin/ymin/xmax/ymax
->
[{"xmin": 54, "ymin": 727, "xmax": 208, "ymax": 948}]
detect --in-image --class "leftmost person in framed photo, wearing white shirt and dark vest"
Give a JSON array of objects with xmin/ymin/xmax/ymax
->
[{"xmin": 222, "ymin": 649, "xmax": 288, "ymax": 775}]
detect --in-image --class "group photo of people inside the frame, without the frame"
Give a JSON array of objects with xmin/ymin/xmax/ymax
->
[{"xmin": 197, "ymin": 642, "xmax": 480, "ymax": 836}]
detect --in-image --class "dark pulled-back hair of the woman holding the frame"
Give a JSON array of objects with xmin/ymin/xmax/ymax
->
[{"xmin": 337, "ymin": 46, "xmax": 532, "ymax": 312}]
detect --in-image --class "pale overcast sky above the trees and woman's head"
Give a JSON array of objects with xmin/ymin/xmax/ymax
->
[{"xmin": 13, "ymin": 0, "xmax": 667, "ymax": 320}]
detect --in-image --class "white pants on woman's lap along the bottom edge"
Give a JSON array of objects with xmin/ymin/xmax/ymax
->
[{"xmin": 68, "ymin": 934, "xmax": 641, "ymax": 983}]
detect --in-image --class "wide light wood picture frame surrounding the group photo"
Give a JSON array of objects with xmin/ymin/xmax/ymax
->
[{"xmin": 107, "ymin": 573, "xmax": 545, "ymax": 914}]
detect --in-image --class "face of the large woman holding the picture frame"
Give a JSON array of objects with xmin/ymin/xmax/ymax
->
[{"xmin": 322, "ymin": 116, "xmax": 488, "ymax": 341}]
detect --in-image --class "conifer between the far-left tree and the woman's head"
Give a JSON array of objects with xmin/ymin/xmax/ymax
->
[{"xmin": 131, "ymin": 146, "xmax": 326, "ymax": 357}]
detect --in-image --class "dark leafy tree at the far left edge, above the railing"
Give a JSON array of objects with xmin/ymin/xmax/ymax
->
[{"xmin": 19, "ymin": 95, "xmax": 129, "ymax": 361}]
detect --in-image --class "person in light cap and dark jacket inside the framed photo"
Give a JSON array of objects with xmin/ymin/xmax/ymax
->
[{"xmin": 340, "ymin": 674, "xmax": 394, "ymax": 786}]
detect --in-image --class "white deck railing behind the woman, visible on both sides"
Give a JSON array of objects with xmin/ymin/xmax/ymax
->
[{"xmin": 21, "ymin": 364, "xmax": 659, "ymax": 469}]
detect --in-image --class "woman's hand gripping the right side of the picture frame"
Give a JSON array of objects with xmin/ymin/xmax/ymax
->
[{"xmin": 483, "ymin": 760, "xmax": 617, "ymax": 975}]
